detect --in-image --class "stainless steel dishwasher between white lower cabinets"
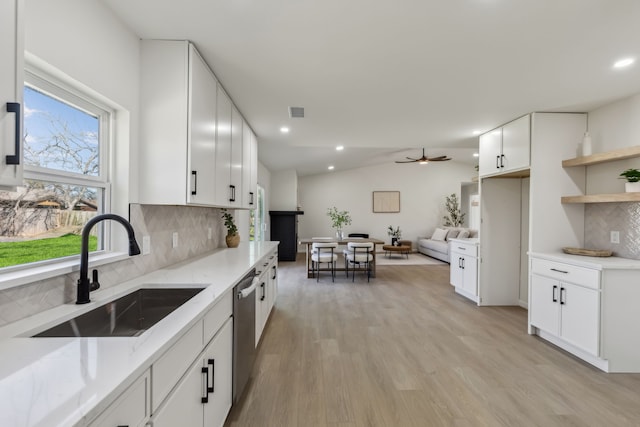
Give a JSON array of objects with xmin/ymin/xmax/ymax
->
[{"xmin": 233, "ymin": 268, "xmax": 258, "ymax": 403}]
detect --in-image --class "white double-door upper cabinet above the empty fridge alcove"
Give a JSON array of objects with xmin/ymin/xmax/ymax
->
[{"xmin": 478, "ymin": 115, "xmax": 531, "ymax": 176}]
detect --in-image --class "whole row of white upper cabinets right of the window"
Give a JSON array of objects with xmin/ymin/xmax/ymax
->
[{"xmin": 140, "ymin": 40, "xmax": 257, "ymax": 208}]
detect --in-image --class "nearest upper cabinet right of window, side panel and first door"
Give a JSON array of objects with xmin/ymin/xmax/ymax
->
[{"xmin": 139, "ymin": 40, "xmax": 217, "ymax": 206}]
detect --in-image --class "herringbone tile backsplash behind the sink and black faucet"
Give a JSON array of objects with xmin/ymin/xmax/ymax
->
[{"xmin": 0, "ymin": 204, "xmax": 226, "ymax": 326}]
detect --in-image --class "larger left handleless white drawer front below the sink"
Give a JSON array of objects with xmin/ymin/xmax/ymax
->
[{"xmin": 151, "ymin": 321, "xmax": 203, "ymax": 411}]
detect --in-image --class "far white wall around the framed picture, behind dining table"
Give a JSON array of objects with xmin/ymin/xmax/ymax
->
[{"xmin": 298, "ymin": 161, "xmax": 475, "ymax": 250}]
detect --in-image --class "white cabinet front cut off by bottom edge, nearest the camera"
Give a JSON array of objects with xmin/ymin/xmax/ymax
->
[{"xmin": 89, "ymin": 370, "xmax": 151, "ymax": 427}]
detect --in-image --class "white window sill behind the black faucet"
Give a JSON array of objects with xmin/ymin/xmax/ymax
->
[{"xmin": 0, "ymin": 252, "xmax": 128, "ymax": 291}]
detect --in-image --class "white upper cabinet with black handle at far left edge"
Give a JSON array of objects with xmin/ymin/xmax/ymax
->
[{"xmin": 0, "ymin": 0, "xmax": 24, "ymax": 190}]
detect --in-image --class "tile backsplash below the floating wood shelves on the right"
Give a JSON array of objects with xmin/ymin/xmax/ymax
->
[{"xmin": 584, "ymin": 203, "xmax": 640, "ymax": 260}]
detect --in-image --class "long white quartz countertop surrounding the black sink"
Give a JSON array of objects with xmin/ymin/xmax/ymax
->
[{"xmin": 0, "ymin": 242, "xmax": 277, "ymax": 427}]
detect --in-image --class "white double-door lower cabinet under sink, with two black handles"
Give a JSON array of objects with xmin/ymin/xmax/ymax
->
[{"xmin": 153, "ymin": 318, "xmax": 233, "ymax": 427}]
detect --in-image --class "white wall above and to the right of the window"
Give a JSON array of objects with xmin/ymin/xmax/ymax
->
[{"xmin": 25, "ymin": 0, "xmax": 140, "ymax": 207}]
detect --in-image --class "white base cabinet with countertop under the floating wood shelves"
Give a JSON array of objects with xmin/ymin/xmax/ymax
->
[{"xmin": 529, "ymin": 253, "xmax": 640, "ymax": 372}]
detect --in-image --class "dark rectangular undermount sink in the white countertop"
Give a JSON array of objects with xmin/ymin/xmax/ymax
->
[{"xmin": 34, "ymin": 288, "xmax": 204, "ymax": 338}]
